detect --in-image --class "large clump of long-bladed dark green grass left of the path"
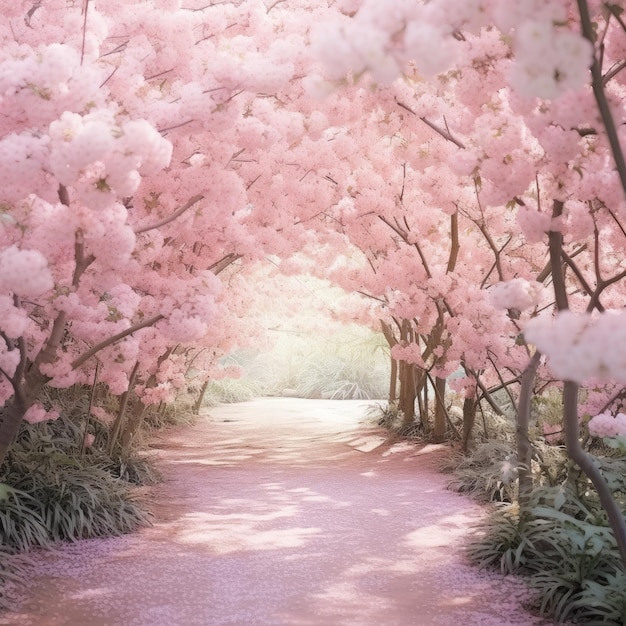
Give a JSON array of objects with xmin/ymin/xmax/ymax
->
[{"xmin": 0, "ymin": 417, "xmax": 148, "ymax": 551}]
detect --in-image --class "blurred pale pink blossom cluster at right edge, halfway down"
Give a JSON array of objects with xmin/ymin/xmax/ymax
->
[{"xmin": 524, "ymin": 310, "xmax": 626, "ymax": 384}]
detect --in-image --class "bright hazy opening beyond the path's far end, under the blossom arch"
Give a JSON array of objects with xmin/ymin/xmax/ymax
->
[{"xmin": 206, "ymin": 259, "xmax": 390, "ymax": 403}]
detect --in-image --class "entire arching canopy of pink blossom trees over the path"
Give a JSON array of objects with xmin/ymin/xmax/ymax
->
[{"xmin": 0, "ymin": 0, "xmax": 626, "ymax": 572}]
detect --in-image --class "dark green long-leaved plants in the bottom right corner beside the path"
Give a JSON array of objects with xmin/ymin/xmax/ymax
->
[{"xmin": 469, "ymin": 458, "xmax": 626, "ymax": 626}]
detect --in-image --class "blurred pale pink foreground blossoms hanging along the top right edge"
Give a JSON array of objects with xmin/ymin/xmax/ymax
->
[{"xmin": 312, "ymin": 0, "xmax": 592, "ymax": 98}]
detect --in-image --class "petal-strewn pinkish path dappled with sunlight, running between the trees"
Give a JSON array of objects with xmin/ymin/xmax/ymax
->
[{"xmin": 0, "ymin": 398, "xmax": 545, "ymax": 626}]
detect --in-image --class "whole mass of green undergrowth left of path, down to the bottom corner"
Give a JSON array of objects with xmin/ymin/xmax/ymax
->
[{"xmin": 0, "ymin": 386, "xmax": 171, "ymax": 609}]
